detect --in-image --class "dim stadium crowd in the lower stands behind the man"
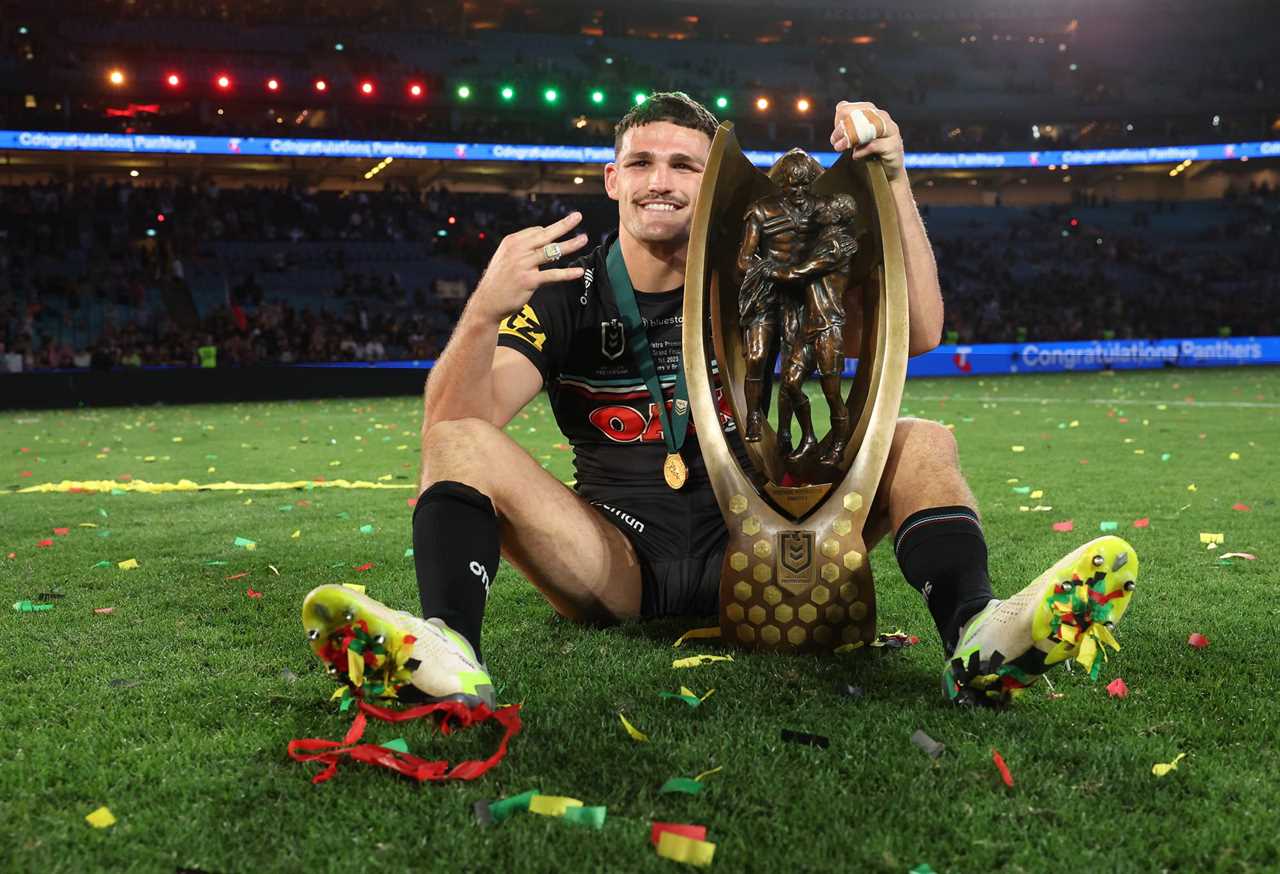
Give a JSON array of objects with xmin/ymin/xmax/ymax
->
[{"xmin": 0, "ymin": 176, "xmax": 1280, "ymax": 371}]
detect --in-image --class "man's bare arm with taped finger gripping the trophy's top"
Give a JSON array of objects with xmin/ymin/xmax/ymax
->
[{"xmin": 831, "ymin": 101, "xmax": 942, "ymax": 356}]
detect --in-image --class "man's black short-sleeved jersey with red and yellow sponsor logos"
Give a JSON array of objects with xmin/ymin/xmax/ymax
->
[{"xmin": 498, "ymin": 233, "xmax": 750, "ymax": 500}]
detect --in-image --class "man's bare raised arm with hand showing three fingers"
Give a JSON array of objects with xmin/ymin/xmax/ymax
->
[{"xmin": 422, "ymin": 212, "xmax": 588, "ymax": 434}]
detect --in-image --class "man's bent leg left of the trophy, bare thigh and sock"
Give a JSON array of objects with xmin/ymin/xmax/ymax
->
[{"xmin": 413, "ymin": 418, "xmax": 641, "ymax": 645}]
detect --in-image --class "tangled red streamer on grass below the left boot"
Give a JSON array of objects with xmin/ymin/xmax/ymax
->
[{"xmin": 288, "ymin": 701, "xmax": 521, "ymax": 783}]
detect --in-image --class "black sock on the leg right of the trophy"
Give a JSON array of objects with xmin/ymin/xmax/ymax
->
[{"xmin": 893, "ymin": 507, "xmax": 993, "ymax": 655}]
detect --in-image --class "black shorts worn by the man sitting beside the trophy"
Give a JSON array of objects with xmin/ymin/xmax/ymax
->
[{"xmin": 584, "ymin": 485, "xmax": 728, "ymax": 619}]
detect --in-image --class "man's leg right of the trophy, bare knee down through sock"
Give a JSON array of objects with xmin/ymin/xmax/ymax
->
[{"xmin": 863, "ymin": 418, "xmax": 992, "ymax": 653}]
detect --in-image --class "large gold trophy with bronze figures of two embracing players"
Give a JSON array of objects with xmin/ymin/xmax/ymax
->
[{"xmin": 684, "ymin": 123, "xmax": 908, "ymax": 650}]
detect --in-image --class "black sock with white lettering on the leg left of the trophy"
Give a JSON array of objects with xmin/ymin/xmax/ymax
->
[{"xmin": 413, "ymin": 480, "xmax": 499, "ymax": 659}]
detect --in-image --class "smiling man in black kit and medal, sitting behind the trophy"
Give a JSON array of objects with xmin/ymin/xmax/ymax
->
[{"xmin": 302, "ymin": 92, "xmax": 1137, "ymax": 704}]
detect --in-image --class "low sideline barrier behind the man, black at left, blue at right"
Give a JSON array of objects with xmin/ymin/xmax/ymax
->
[{"xmin": 0, "ymin": 337, "xmax": 1280, "ymax": 409}]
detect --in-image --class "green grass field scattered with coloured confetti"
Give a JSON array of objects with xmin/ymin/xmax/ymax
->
[{"xmin": 0, "ymin": 370, "xmax": 1280, "ymax": 874}]
